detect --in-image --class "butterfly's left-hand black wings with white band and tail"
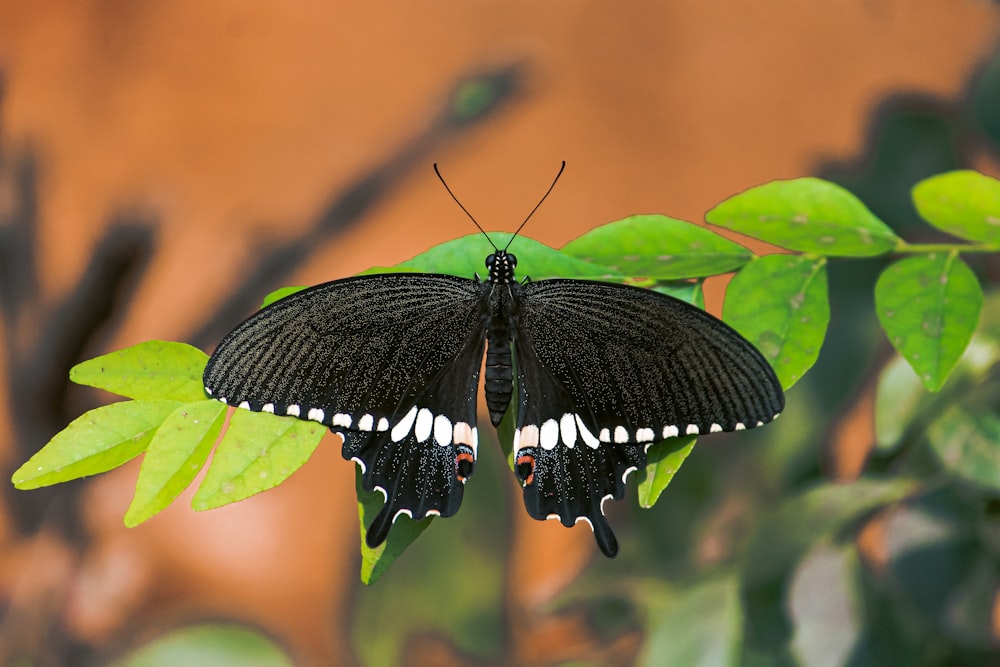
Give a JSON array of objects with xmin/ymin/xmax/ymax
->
[{"xmin": 205, "ymin": 274, "xmax": 486, "ymax": 546}]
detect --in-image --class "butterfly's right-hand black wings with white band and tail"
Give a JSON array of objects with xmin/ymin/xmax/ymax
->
[{"xmin": 513, "ymin": 280, "xmax": 784, "ymax": 555}]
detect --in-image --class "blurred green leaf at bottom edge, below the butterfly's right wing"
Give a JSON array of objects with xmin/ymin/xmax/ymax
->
[{"xmin": 638, "ymin": 576, "xmax": 743, "ymax": 667}]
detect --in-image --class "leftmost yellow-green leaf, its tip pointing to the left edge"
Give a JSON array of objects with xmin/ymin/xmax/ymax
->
[{"xmin": 11, "ymin": 401, "xmax": 181, "ymax": 489}]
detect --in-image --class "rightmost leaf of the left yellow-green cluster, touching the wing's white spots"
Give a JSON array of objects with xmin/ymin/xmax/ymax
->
[{"xmin": 191, "ymin": 409, "xmax": 326, "ymax": 512}]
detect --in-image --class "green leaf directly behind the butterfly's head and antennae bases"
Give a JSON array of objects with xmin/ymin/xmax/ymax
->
[{"xmin": 399, "ymin": 232, "xmax": 622, "ymax": 280}]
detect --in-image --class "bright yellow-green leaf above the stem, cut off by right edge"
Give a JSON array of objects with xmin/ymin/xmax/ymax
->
[{"xmin": 913, "ymin": 171, "xmax": 1000, "ymax": 244}]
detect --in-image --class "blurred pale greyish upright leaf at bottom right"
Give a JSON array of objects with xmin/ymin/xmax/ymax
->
[{"xmin": 788, "ymin": 541, "xmax": 864, "ymax": 667}]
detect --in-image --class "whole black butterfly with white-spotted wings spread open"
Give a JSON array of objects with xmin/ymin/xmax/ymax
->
[{"xmin": 204, "ymin": 167, "xmax": 784, "ymax": 556}]
